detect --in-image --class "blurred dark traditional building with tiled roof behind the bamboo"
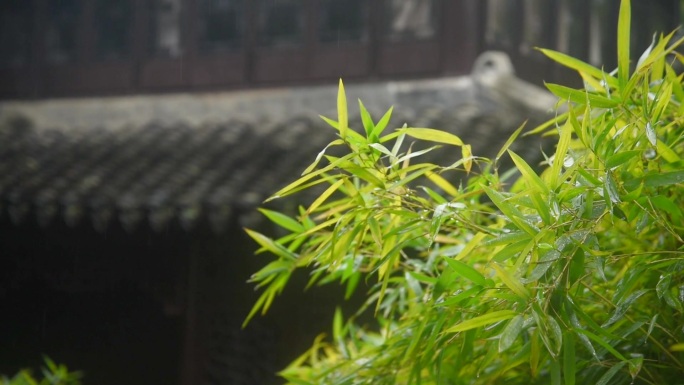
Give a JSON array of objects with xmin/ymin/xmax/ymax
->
[{"xmin": 0, "ymin": 0, "xmax": 681, "ymax": 385}]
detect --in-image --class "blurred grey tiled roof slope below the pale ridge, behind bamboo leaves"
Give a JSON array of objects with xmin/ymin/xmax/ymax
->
[{"xmin": 0, "ymin": 50, "xmax": 546, "ymax": 231}]
